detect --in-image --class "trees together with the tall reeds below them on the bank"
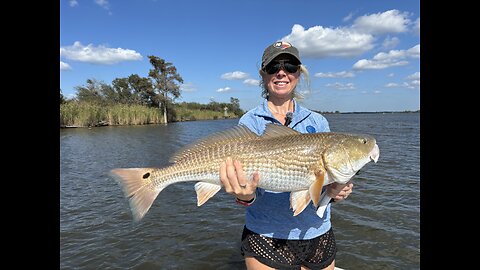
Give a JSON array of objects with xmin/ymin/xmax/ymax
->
[{"xmin": 60, "ymin": 55, "xmax": 244, "ymax": 127}]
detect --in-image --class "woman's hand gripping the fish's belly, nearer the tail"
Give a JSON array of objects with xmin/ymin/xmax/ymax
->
[{"xmin": 220, "ymin": 157, "xmax": 260, "ymax": 201}]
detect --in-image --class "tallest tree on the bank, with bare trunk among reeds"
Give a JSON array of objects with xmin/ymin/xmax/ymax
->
[{"xmin": 148, "ymin": 55, "xmax": 183, "ymax": 124}]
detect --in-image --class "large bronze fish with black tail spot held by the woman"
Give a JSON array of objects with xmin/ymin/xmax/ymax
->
[{"xmin": 111, "ymin": 124, "xmax": 379, "ymax": 221}]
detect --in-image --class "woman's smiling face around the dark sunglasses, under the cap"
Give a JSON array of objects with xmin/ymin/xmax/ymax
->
[{"xmin": 262, "ymin": 55, "xmax": 300, "ymax": 98}]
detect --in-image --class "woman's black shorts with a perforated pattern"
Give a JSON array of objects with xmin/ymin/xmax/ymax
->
[{"xmin": 241, "ymin": 227, "xmax": 337, "ymax": 269}]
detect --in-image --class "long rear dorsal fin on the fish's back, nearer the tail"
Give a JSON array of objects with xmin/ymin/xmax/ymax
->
[{"xmin": 170, "ymin": 125, "xmax": 260, "ymax": 163}]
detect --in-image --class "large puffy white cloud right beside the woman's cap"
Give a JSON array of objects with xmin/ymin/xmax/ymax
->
[{"xmin": 282, "ymin": 24, "xmax": 374, "ymax": 58}]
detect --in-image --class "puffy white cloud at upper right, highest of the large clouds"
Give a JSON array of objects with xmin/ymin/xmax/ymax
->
[{"xmin": 352, "ymin": 9, "xmax": 411, "ymax": 34}]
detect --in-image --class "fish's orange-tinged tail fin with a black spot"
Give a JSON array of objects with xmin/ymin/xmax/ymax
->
[{"xmin": 110, "ymin": 168, "xmax": 161, "ymax": 221}]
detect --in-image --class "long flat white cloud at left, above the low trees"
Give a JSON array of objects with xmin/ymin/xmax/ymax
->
[{"xmin": 60, "ymin": 41, "xmax": 142, "ymax": 65}]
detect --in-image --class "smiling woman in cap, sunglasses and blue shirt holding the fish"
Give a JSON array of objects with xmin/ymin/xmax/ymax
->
[{"xmin": 220, "ymin": 41, "xmax": 353, "ymax": 269}]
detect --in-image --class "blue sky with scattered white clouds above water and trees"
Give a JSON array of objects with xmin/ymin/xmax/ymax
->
[{"xmin": 60, "ymin": 0, "xmax": 420, "ymax": 112}]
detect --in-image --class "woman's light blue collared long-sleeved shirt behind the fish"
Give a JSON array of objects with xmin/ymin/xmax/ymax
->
[{"xmin": 239, "ymin": 100, "xmax": 331, "ymax": 239}]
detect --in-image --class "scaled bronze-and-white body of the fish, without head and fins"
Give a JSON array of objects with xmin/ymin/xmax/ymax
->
[{"xmin": 165, "ymin": 139, "xmax": 321, "ymax": 191}]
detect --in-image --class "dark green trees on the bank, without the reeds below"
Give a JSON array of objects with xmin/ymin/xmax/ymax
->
[{"xmin": 60, "ymin": 55, "xmax": 244, "ymax": 123}]
